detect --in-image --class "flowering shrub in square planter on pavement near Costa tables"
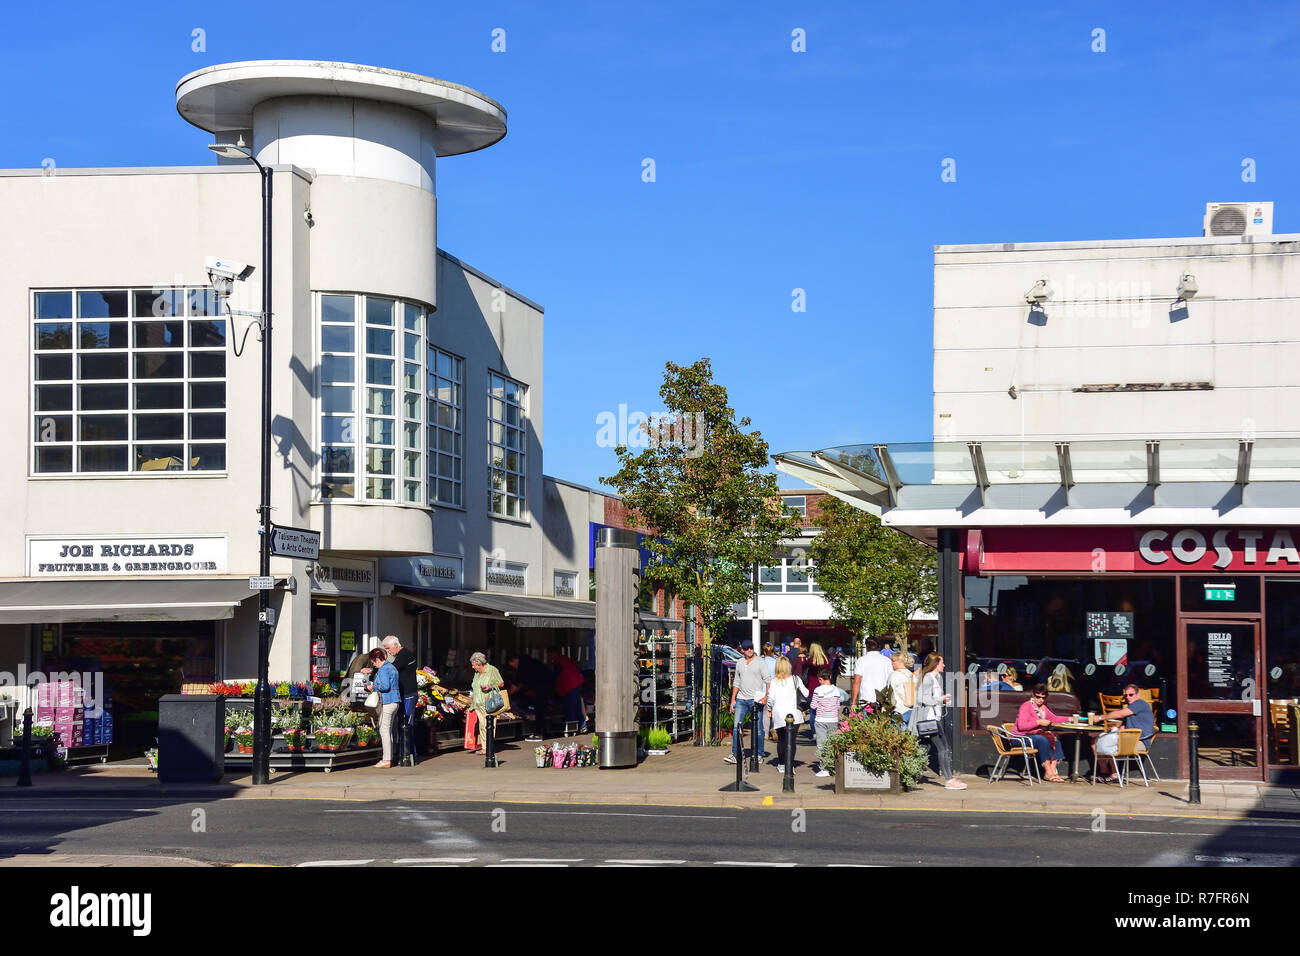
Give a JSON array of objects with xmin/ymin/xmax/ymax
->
[{"xmin": 819, "ymin": 704, "xmax": 928, "ymax": 793}]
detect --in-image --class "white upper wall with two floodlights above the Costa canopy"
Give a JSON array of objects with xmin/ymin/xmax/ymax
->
[{"xmin": 933, "ymin": 237, "xmax": 1300, "ymax": 441}]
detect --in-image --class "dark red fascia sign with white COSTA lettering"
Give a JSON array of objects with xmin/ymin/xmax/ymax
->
[{"xmin": 962, "ymin": 527, "xmax": 1300, "ymax": 574}]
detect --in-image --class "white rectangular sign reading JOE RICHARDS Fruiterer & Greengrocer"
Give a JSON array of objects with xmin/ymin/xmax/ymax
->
[{"xmin": 27, "ymin": 535, "xmax": 228, "ymax": 578}]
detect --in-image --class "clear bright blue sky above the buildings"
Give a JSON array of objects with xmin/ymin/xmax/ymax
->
[{"xmin": 0, "ymin": 3, "xmax": 1300, "ymax": 484}]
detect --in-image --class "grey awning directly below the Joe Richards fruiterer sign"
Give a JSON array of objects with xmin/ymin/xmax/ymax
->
[{"xmin": 0, "ymin": 578, "xmax": 257, "ymax": 624}]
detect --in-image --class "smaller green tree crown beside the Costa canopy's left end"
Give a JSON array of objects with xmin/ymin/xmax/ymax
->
[{"xmin": 809, "ymin": 496, "xmax": 939, "ymax": 650}]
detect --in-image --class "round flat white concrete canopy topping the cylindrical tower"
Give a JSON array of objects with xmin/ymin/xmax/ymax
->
[{"xmin": 176, "ymin": 60, "xmax": 506, "ymax": 156}]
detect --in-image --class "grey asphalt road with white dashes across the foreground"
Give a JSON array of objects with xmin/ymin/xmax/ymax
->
[{"xmin": 0, "ymin": 797, "xmax": 1300, "ymax": 868}]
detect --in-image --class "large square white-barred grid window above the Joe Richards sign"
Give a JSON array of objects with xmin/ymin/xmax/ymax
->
[{"xmin": 31, "ymin": 289, "xmax": 226, "ymax": 475}]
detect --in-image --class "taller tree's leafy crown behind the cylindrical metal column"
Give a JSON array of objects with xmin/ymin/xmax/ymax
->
[{"xmin": 601, "ymin": 358, "xmax": 801, "ymax": 642}]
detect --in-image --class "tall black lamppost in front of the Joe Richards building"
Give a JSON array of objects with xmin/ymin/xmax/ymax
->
[{"xmin": 208, "ymin": 143, "xmax": 272, "ymax": 784}]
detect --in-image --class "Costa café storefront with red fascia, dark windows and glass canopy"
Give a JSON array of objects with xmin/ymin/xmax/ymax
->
[{"xmin": 777, "ymin": 440, "xmax": 1300, "ymax": 780}]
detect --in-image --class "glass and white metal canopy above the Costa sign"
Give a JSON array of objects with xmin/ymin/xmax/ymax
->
[{"xmin": 774, "ymin": 437, "xmax": 1300, "ymax": 541}]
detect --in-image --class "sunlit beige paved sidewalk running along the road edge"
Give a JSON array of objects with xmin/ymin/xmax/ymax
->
[{"xmin": 10, "ymin": 736, "xmax": 1300, "ymax": 818}]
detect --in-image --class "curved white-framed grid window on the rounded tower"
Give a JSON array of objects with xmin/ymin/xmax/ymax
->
[{"xmin": 319, "ymin": 294, "xmax": 425, "ymax": 505}]
